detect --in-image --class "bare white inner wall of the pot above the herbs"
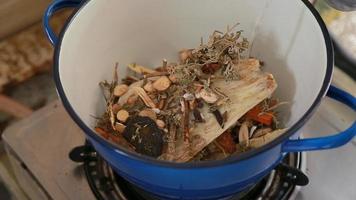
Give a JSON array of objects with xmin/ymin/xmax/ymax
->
[{"xmin": 59, "ymin": 0, "xmax": 327, "ymax": 134}]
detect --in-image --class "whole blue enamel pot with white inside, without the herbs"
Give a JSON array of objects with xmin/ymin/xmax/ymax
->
[{"xmin": 44, "ymin": 0, "xmax": 356, "ymax": 199}]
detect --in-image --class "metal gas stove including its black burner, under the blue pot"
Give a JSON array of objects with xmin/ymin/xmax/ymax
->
[{"xmin": 3, "ymin": 68, "xmax": 356, "ymax": 200}]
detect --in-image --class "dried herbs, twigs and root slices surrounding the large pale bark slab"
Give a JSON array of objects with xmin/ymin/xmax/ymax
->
[{"xmin": 95, "ymin": 25, "xmax": 283, "ymax": 162}]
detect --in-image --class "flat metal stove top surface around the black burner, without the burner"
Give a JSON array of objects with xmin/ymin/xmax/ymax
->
[{"xmin": 3, "ymin": 68, "xmax": 356, "ymax": 200}]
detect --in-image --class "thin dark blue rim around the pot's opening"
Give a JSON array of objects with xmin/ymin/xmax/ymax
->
[{"xmin": 53, "ymin": 0, "xmax": 334, "ymax": 169}]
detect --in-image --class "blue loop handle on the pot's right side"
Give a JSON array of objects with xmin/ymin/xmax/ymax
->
[{"xmin": 282, "ymin": 86, "xmax": 356, "ymax": 152}]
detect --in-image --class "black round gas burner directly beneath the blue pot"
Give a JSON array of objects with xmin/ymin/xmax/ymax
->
[{"xmin": 69, "ymin": 143, "xmax": 308, "ymax": 200}]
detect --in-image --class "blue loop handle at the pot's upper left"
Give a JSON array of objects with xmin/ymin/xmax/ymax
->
[{"xmin": 42, "ymin": 0, "xmax": 82, "ymax": 46}]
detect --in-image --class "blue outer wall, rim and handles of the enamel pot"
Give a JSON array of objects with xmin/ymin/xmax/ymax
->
[{"xmin": 43, "ymin": 0, "xmax": 356, "ymax": 199}]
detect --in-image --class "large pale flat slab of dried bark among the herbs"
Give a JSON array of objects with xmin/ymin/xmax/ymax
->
[{"xmin": 162, "ymin": 68, "xmax": 277, "ymax": 162}]
